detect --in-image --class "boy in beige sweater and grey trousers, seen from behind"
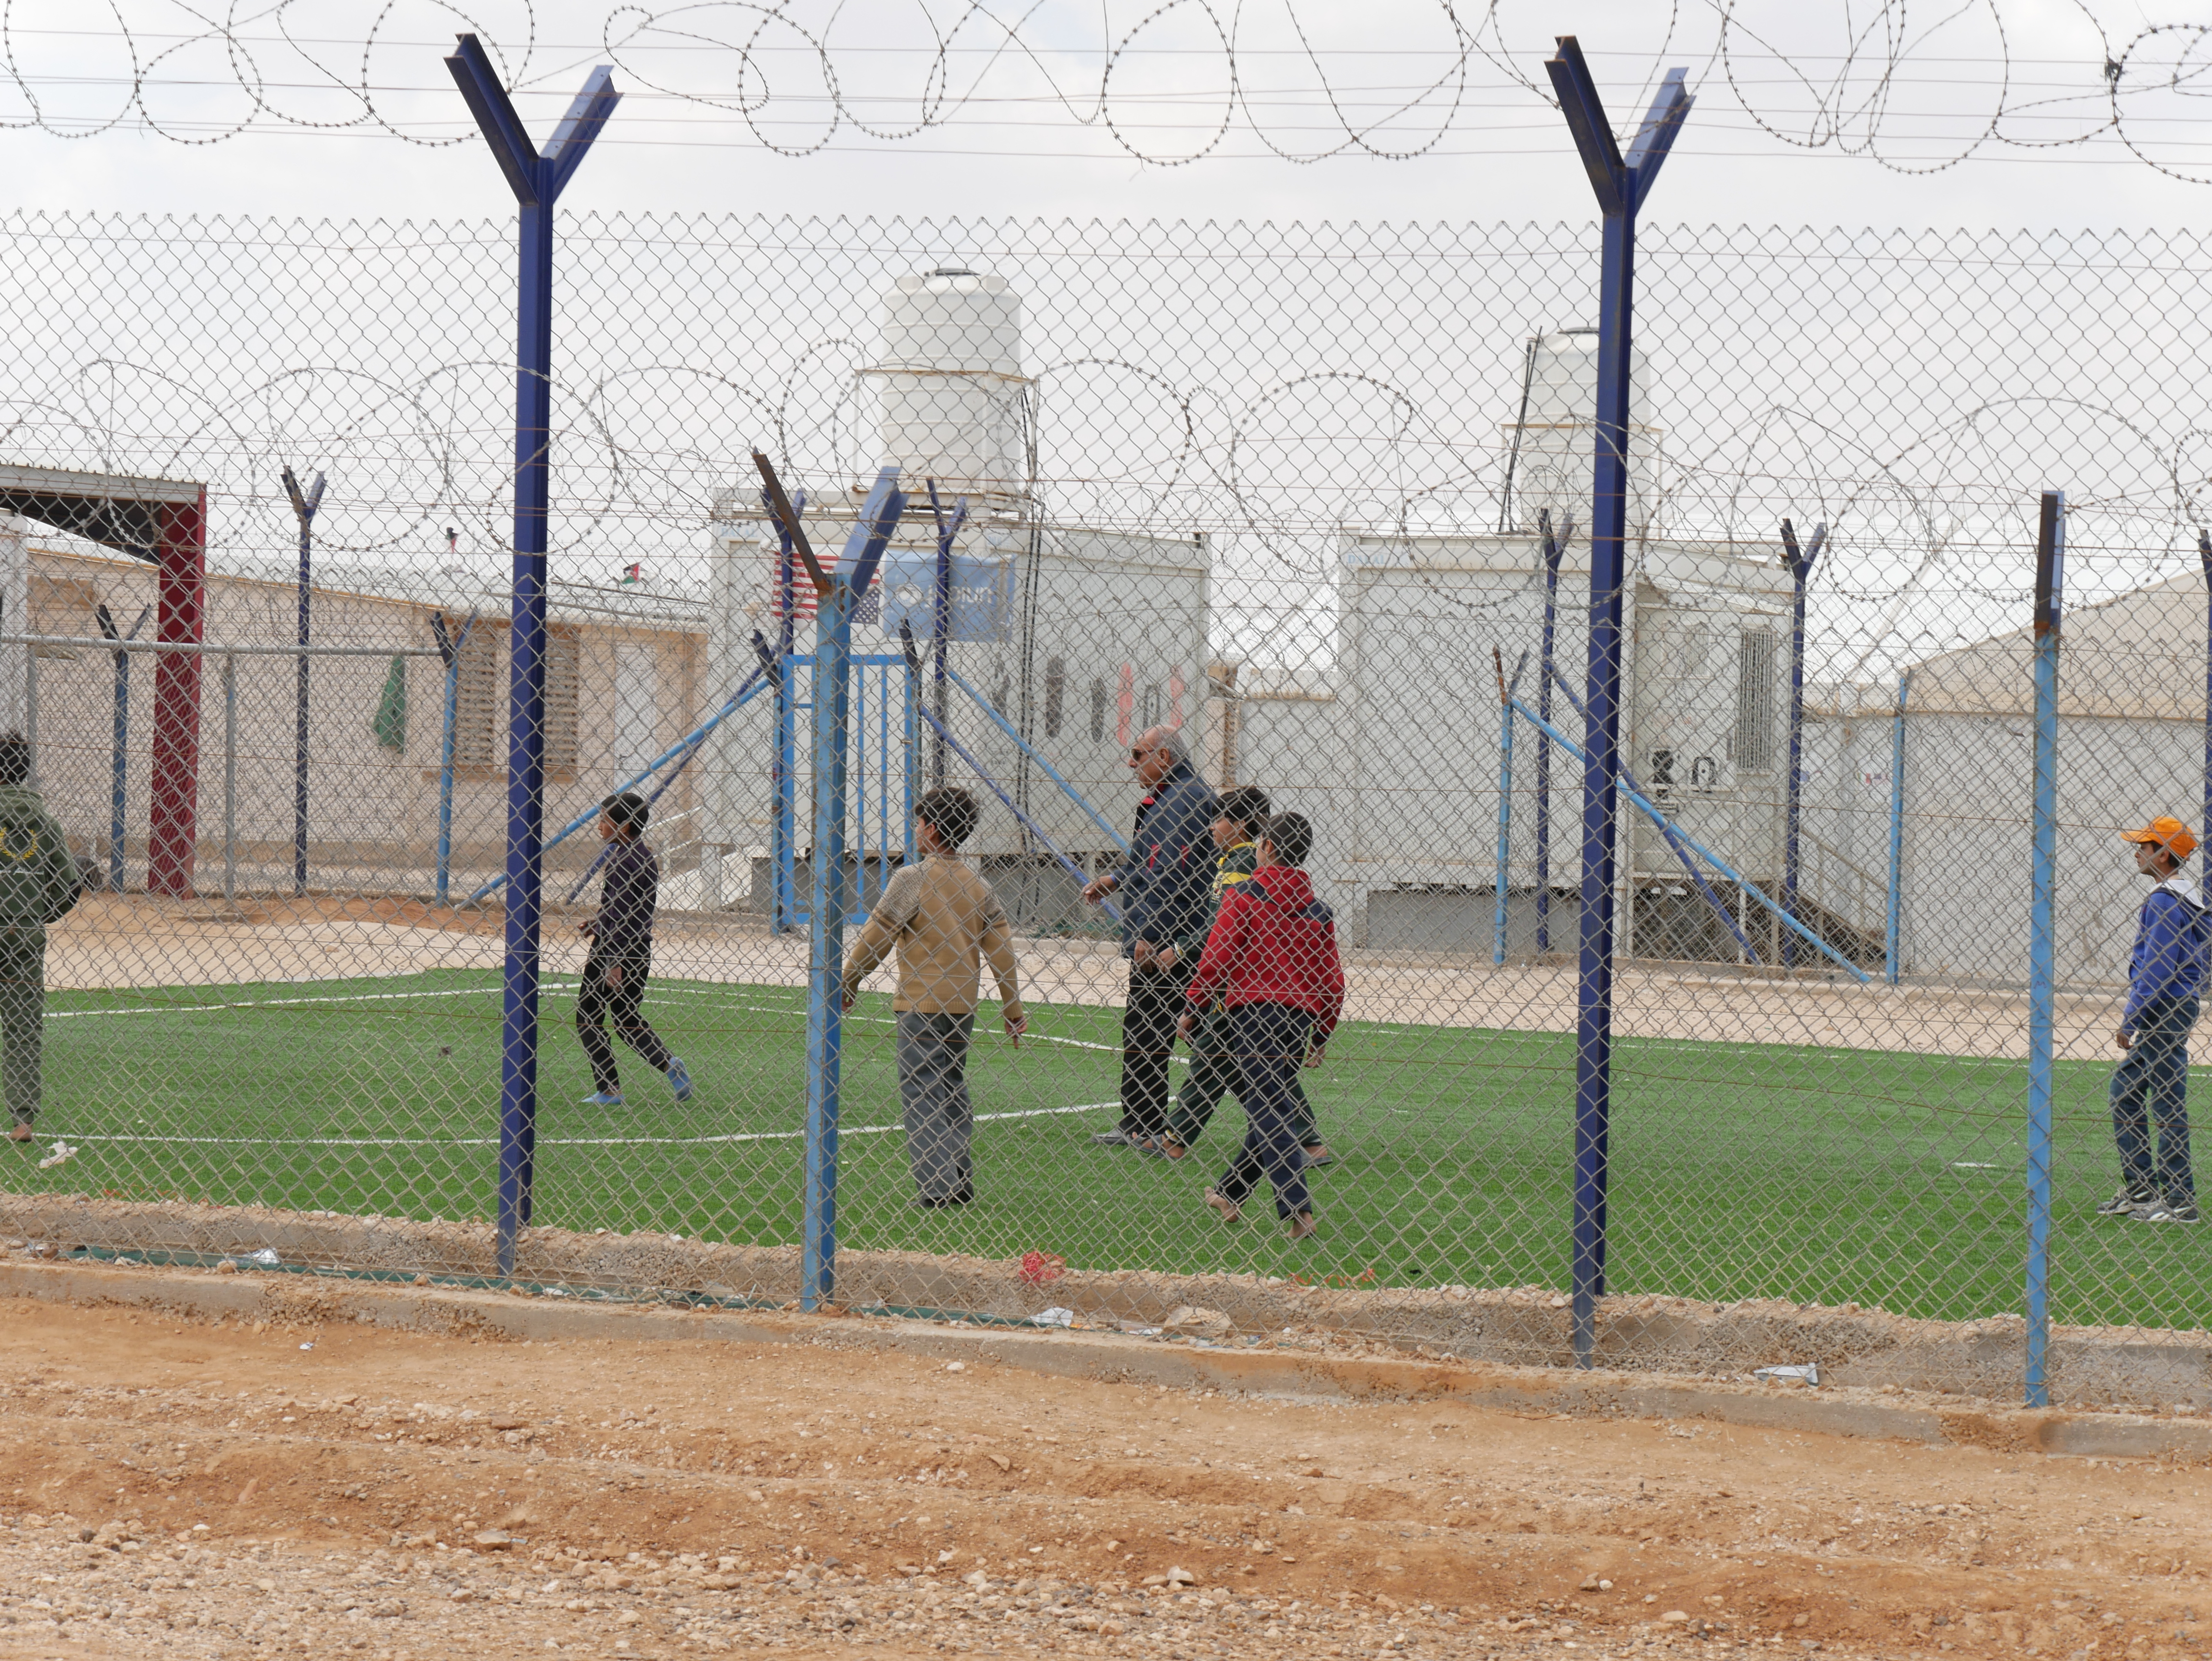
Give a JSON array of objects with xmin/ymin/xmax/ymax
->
[{"xmin": 845, "ymin": 785, "xmax": 1028, "ymax": 1210}]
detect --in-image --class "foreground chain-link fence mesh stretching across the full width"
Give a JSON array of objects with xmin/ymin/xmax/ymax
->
[{"xmin": 0, "ymin": 204, "xmax": 2212, "ymax": 1400}]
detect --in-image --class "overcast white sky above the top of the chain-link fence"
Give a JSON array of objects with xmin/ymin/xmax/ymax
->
[{"xmin": 0, "ymin": 0, "xmax": 2212, "ymax": 228}]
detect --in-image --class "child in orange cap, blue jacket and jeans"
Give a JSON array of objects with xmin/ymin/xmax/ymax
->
[{"xmin": 2097, "ymin": 818, "xmax": 2212, "ymax": 1223}]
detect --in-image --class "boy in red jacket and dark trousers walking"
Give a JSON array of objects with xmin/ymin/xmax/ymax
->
[{"xmin": 1181, "ymin": 814, "xmax": 1345, "ymax": 1241}]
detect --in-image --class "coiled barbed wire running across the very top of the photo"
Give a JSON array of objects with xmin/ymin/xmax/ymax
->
[{"xmin": 13, "ymin": 0, "xmax": 2212, "ymax": 184}]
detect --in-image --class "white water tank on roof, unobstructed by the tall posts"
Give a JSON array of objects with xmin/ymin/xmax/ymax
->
[{"xmin": 867, "ymin": 265, "xmax": 1028, "ymax": 511}]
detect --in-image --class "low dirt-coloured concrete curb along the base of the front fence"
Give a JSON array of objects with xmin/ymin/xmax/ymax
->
[{"xmin": 13, "ymin": 1263, "xmax": 2212, "ymax": 1462}]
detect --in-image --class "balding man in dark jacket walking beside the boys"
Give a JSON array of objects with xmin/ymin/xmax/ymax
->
[{"xmin": 1084, "ymin": 728, "xmax": 1221, "ymax": 1148}]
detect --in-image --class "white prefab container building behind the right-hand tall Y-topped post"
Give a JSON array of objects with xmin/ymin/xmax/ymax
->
[{"xmin": 1234, "ymin": 535, "xmax": 1790, "ymax": 951}]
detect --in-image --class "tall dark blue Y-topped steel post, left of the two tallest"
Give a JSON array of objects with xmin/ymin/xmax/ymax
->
[{"xmin": 445, "ymin": 35, "xmax": 621, "ymax": 1274}]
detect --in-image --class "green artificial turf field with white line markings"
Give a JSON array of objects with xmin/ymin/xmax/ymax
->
[{"xmin": 4, "ymin": 971, "xmax": 2212, "ymax": 1327}]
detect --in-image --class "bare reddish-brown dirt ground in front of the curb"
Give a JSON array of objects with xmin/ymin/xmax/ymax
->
[{"xmin": 0, "ymin": 1301, "xmax": 2212, "ymax": 1661}]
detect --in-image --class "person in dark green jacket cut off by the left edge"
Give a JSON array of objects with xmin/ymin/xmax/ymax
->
[{"xmin": 0, "ymin": 732, "xmax": 84, "ymax": 1141}]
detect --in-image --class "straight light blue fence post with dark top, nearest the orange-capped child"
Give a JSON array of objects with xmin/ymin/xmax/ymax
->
[{"xmin": 2026, "ymin": 491, "xmax": 2066, "ymax": 1407}]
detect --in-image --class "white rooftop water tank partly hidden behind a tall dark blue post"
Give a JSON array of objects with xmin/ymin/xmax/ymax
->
[{"xmin": 1502, "ymin": 330, "xmax": 1659, "ymax": 540}]
